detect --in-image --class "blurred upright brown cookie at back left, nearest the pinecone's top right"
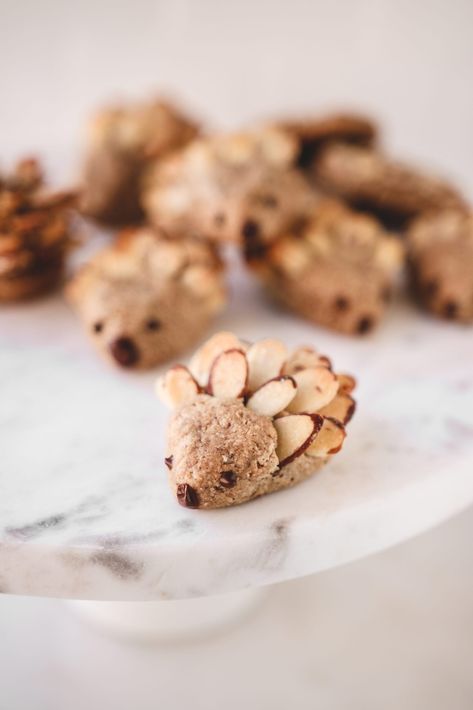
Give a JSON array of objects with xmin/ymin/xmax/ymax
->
[{"xmin": 81, "ymin": 100, "xmax": 199, "ymax": 225}]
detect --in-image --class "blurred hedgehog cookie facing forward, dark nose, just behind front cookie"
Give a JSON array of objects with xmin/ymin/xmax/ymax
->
[{"xmin": 66, "ymin": 228, "xmax": 225, "ymax": 369}]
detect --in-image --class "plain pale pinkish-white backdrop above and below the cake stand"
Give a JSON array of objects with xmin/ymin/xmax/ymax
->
[{"xmin": 0, "ymin": 0, "xmax": 473, "ymax": 710}]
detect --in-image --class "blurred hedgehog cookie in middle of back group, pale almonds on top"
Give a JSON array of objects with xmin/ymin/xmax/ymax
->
[{"xmin": 143, "ymin": 127, "xmax": 314, "ymax": 249}]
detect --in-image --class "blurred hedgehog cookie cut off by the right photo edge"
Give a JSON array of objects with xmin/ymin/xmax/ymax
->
[{"xmin": 407, "ymin": 210, "xmax": 473, "ymax": 323}]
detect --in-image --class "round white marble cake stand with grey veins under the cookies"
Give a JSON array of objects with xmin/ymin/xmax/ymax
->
[{"xmin": 0, "ymin": 253, "xmax": 473, "ymax": 644}]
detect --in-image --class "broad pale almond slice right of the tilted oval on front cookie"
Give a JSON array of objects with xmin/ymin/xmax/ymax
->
[{"xmin": 288, "ymin": 366, "xmax": 338, "ymax": 413}]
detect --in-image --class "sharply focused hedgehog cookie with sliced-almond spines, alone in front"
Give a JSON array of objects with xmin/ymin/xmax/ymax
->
[{"xmin": 157, "ymin": 332, "xmax": 355, "ymax": 508}]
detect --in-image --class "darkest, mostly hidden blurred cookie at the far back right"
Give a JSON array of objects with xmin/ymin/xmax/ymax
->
[{"xmin": 276, "ymin": 113, "xmax": 378, "ymax": 168}]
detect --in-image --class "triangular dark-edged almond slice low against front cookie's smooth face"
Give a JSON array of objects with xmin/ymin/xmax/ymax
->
[{"xmin": 274, "ymin": 414, "xmax": 323, "ymax": 468}]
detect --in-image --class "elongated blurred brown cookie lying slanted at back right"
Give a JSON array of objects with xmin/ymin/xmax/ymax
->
[{"xmin": 313, "ymin": 144, "xmax": 465, "ymax": 227}]
